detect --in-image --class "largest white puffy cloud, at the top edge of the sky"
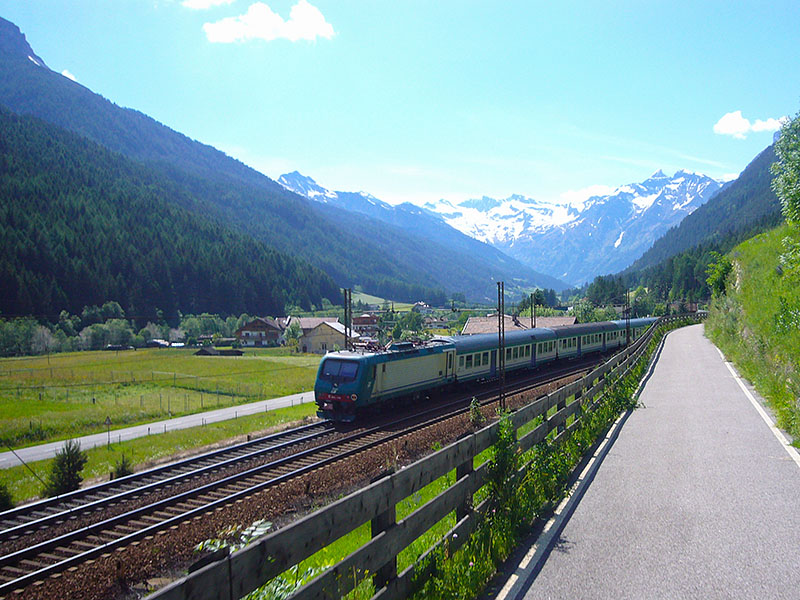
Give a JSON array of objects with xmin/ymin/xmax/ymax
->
[{"xmin": 203, "ymin": 0, "xmax": 334, "ymax": 44}]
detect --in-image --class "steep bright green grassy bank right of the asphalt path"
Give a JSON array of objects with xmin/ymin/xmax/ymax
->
[{"xmin": 706, "ymin": 225, "xmax": 800, "ymax": 446}]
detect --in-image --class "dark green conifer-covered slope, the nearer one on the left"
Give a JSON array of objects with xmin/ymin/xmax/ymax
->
[{"xmin": 0, "ymin": 110, "xmax": 339, "ymax": 318}]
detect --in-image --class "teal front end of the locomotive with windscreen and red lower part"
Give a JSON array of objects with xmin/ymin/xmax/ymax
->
[{"xmin": 314, "ymin": 352, "xmax": 369, "ymax": 422}]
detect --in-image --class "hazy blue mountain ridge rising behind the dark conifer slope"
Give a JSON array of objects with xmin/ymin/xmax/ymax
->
[{"xmin": 0, "ymin": 19, "xmax": 552, "ymax": 302}]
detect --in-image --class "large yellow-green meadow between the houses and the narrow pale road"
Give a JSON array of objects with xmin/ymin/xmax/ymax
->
[{"xmin": 0, "ymin": 348, "xmax": 320, "ymax": 448}]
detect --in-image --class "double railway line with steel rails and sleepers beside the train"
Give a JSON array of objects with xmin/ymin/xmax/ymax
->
[{"xmin": 0, "ymin": 356, "xmax": 590, "ymax": 596}]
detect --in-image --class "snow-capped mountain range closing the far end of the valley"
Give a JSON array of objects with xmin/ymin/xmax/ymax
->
[{"xmin": 278, "ymin": 170, "xmax": 723, "ymax": 289}]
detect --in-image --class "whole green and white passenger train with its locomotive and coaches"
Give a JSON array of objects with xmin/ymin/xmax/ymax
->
[{"xmin": 314, "ymin": 317, "xmax": 657, "ymax": 422}]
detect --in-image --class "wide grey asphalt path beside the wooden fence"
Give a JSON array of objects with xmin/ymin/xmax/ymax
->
[{"xmin": 492, "ymin": 325, "xmax": 800, "ymax": 600}]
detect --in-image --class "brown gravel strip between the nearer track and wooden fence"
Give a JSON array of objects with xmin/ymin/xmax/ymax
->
[{"xmin": 8, "ymin": 375, "xmax": 579, "ymax": 600}]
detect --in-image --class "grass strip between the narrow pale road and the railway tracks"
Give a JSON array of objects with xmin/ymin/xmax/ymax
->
[{"xmin": 0, "ymin": 403, "xmax": 316, "ymax": 503}]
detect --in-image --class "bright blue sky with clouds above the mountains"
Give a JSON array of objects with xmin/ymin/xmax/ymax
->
[{"xmin": 0, "ymin": 0, "xmax": 800, "ymax": 203}]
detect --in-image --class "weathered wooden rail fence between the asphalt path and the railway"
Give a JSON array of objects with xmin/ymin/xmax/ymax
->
[{"xmin": 150, "ymin": 317, "xmax": 700, "ymax": 600}]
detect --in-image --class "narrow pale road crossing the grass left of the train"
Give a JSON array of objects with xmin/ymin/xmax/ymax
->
[{"xmin": 0, "ymin": 392, "xmax": 314, "ymax": 469}]
